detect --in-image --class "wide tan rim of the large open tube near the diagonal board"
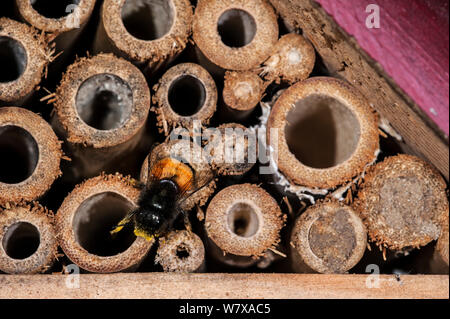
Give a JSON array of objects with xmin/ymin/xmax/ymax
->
[{"xmin": 267, "ymin": 77, "xmax": 379, "ymax": 188}]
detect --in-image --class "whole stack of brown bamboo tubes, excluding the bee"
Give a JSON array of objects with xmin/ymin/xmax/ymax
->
[{"xmin": 0, "ymin": 0, "xmax": 449, "ymax": 274}]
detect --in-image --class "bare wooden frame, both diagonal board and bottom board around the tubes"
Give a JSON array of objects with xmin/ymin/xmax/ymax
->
[{"xmin": 0, "ymin": 0, "xmax": 449, "ymax": 299}]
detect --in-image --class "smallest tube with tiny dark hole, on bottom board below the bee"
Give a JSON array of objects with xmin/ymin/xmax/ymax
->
[{"xmin": 155, "ymin": 230, "xmax": 205, "ymax": 272}]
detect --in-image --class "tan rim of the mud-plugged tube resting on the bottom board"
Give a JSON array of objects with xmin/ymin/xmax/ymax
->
[{"xmin": 291, "ymin": 202, "xmax": 367, "ymax": 273}]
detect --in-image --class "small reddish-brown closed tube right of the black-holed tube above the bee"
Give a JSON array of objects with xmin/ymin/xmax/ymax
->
[{"xmin": 223, "ymin": 71, "xmax": 266, "ymax": 120}]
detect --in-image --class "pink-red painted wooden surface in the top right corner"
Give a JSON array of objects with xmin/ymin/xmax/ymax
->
[{"xmin": 317, "ymin": 0, "xmax": 449, "ymax": 136}]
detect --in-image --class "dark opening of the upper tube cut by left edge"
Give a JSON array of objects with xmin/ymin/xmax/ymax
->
[{"xmin": 0, "ymin": 36, "xmax": 27, "ymax": 83}]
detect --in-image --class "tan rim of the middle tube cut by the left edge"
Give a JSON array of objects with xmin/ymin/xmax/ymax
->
[{"xmin": 0, "ymin": 107, "xmax": 62, "ymax": 205}]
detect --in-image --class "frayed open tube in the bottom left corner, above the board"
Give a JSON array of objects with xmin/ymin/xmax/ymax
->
[{"xmin": 0, "ymin": 203, "xmax": 58, "ymax": 274}]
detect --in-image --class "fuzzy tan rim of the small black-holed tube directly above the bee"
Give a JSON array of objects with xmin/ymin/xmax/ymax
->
[{"xmin": 152, "ymin": 63, "xmax": 217, "ymax": 135}]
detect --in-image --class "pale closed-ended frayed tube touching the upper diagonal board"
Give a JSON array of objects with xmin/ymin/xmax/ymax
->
[{"xmin": 262, "ymin": 33, "xmax": 316, "ymax": 84}]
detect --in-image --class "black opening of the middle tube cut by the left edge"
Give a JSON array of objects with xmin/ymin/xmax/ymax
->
[{"xmin": 0, "ymin": 125, "xmax": 39, "ymax": 184}]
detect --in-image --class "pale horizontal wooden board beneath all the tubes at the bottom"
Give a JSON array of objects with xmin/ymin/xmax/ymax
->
[{"xmin": 0, "ymin": 273, "xmax": 449, "ymax": 299}]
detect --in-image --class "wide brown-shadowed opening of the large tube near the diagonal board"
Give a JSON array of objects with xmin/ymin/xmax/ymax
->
[{"xmin": 285, "ymin": 95, "xmax": 361, "ymax": 169}]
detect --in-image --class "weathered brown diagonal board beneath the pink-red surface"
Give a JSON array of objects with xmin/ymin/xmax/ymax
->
[{"xmin": 270, "ymin": 0, "xmax": 449, "ymax": 181}]
